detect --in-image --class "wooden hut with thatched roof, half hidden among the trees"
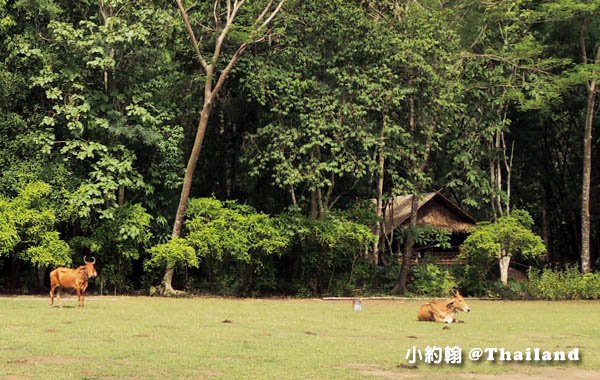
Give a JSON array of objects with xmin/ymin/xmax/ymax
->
[{"xmin": 377, "ymin": 192, "xmax": 475, "ymax": 265}]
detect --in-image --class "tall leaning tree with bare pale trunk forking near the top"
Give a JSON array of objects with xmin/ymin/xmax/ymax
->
[{"xmin": 162, "ymin": 0, "xmax": 285, "ymax": 294}]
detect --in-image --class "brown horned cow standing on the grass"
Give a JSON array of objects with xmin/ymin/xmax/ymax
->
[{"xmin": 50, "ymin": 256, "xmax": 98, "ymax": 307}]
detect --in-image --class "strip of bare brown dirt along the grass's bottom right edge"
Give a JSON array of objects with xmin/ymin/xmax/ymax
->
[{"xmin": 341, "ymin": 364, "xmax": 600, "ymax": 380}]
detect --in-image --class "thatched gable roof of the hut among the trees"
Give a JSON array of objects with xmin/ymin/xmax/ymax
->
[{"xmin": 378, "ymin": 192, "xmax": 475, "ymax": 234}]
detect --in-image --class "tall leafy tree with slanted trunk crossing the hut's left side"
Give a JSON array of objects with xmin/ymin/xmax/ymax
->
[{"xmin": 380, "ymin": 4, "xmax": 463, "ymax": 293}]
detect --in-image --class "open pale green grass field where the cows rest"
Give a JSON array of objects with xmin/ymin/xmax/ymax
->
[{"xmin": 0, "ymin": 297, "xmax": 600, "ymax": 379}]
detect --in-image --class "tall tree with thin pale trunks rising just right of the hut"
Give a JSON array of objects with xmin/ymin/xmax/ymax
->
[{"xmin": 463, "ymin": 0, "xmax": 565, "ymax": 219}]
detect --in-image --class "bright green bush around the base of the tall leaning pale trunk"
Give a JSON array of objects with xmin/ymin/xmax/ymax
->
[{"xmin": 146, "ymin": 198, "xmax": 290, "ymax": 295}]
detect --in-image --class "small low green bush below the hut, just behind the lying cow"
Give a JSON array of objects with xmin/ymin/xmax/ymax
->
[{"xmin": 412, "ymin": 264, "xmax": 457, "ymax": 297}]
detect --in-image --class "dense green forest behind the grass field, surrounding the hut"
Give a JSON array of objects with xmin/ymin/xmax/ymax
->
[{"xmin": 0, "ymin": 0, "xmax": 600, "ymax": 297}]
